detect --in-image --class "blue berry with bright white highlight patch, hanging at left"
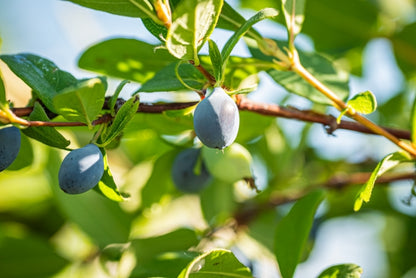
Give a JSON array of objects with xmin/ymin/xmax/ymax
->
[{"xmin": 58, "ymin": 144, "xmax": 104, "ymax": 194}]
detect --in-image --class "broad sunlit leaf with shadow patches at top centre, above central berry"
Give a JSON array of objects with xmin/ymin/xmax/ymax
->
[{"xmin": 166, "ymin": 0, "xmax": 223, "ymax": 65}]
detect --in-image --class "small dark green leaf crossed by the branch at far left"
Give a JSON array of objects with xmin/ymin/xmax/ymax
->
[{"xmin": 22, "ymin": 102, "xmax": 70, "ymax": 149}]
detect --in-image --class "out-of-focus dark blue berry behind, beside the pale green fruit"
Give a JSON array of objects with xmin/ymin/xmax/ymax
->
[{"xmin": 171, "ymin": 149, "xmax": 212, "ymax": 193}]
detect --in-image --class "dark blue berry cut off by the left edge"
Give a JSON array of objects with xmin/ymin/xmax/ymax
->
[{"xmin": 0, "ymin": 126, "xmax": 21, "ymax": 172}]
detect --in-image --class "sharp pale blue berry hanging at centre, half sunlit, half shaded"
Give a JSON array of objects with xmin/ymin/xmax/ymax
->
[{"xmin": 194, "ymin": 87, "xmax": 240, "ymax": 149}]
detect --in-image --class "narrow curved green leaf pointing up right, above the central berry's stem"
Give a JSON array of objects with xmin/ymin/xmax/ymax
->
[{"xmin": 221, "ymin": 8, "xmax": 278, "ymax": 66}]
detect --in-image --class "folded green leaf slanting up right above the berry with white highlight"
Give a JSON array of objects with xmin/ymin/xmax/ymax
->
[{"xmin": 102, "ymin": 97, "xmax": 140, "ymax": 145}]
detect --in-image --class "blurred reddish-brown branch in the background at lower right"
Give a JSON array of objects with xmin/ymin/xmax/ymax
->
[{"xmin": 234, "ymin": 172, "xmax": 416, "ymax": 226}]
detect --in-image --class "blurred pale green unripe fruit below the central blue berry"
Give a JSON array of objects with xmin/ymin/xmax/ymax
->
[{"xmin": 202, "ymin": 143, "xmax": 252, "ymax": 183}]
